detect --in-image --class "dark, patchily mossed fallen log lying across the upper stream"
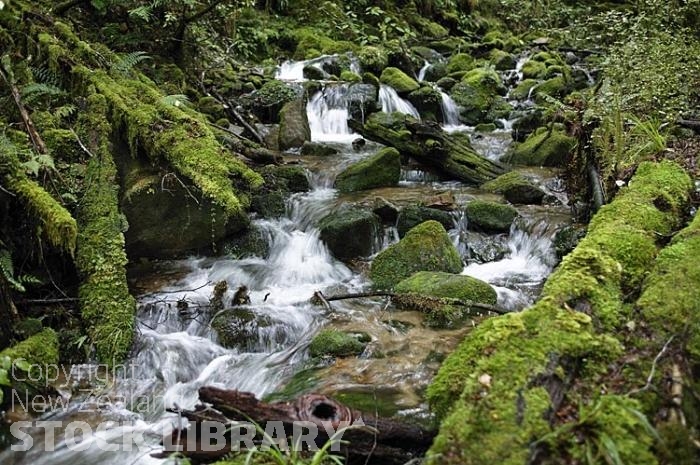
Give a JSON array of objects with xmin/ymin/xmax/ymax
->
[{"xmin": 349, "ymin": 113, "xmax": 507, "ymax": 184}]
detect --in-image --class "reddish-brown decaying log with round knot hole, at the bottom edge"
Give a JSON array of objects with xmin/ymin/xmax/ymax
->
[{"xmin": 154, "ymin": 386, "xmax": 434, "ymax": 465}]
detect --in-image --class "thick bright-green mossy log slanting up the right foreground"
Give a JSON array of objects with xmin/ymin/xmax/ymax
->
[{"xmin": 428, "ymin": 162, "xmax": 691, "ymax": 465}]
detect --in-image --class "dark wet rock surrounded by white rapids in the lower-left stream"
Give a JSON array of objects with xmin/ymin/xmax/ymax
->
[{"xmin": 211, "ymin": 308, "xmax": 272, "ymax": 350}]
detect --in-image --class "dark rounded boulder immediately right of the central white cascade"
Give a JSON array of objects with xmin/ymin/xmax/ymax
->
[{"xmin": 318, "ymin": 206, "xmax": 381, "ymax": 260}]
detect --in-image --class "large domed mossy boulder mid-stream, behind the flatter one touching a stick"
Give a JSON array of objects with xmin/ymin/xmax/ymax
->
[{"xmin": 370, "ymin": 220, "xmax": 462, "ymax": 289}]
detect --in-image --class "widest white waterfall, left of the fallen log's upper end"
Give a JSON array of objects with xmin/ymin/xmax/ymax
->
[{"xmin": 306, "ymin": 85, "xmax": 357, "ymax": 142}]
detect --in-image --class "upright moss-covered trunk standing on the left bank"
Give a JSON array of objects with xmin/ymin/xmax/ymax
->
[{"xmin": 76, "ymin": 94, "xmax": 136, "ymax": 363}]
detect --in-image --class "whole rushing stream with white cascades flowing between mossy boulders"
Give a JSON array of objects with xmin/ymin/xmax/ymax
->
[{"xmin": 0, "ymin": 51, "xmax": 570, "ymax": 465}]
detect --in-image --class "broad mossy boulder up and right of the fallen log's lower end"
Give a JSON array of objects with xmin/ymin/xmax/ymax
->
[{"xmin": 509, "ymin": 128, "xmax": 576, "ymax": 166}]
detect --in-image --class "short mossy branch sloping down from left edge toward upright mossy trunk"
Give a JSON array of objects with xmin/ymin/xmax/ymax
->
[{"xmin": 0, "ymin": 150, "xmax": 78, "ymax": 256}]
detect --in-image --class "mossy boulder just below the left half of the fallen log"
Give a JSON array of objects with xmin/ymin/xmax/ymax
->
[{"xmin": 335, "ymin": 147, "xmax": 401, "ymax": 192}]
